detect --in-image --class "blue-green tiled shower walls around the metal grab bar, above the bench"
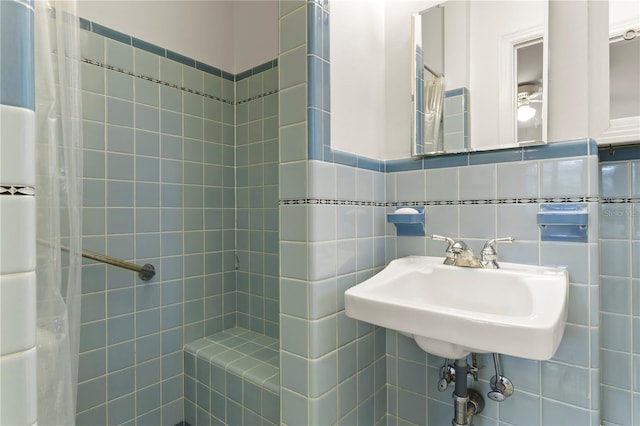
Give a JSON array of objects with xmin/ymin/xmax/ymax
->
[{"xmin": 77, "ymin": 21, "xmax": 278, "ymax": 425}]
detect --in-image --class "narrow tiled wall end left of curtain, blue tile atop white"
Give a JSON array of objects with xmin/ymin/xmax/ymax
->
[{"xmin": 0, "ymin": 1, "xmax": 38, "ymax": 425}]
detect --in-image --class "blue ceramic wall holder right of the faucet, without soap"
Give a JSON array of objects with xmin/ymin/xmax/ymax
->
[{"xmin": 538, "ymin": 203, "xmax": 589, "ymax": 243}]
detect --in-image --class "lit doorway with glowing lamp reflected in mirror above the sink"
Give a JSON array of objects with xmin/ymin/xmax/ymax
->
[{"xmin": 515, "ymin": 40, "xmax": 544, "ymax": 144}]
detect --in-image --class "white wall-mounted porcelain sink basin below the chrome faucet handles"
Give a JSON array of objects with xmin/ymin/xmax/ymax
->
[{"xmin": 344, "ymin": 256, "xmax": 569, "ymax": 360}]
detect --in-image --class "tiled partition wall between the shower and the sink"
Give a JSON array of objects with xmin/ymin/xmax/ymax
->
[{"xmin": 279, "ymin": 2, "xmax": 386, "ymax": 425}]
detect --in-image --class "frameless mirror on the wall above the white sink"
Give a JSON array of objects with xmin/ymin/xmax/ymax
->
[{"xmin": 411, "ymin": 1, "xmax": 548, "ymax": 156}]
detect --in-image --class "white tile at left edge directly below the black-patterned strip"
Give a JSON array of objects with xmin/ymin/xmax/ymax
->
[{"xmin": 0, "ymin": 195, "xmax": 36, "ymax": 274}]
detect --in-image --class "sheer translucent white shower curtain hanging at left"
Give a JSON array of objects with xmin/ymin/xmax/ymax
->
[{"xmin": 34, "ymin": 0, "xmax": 82, "ymax": 426}]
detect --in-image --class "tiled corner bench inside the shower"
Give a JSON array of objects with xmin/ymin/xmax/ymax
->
[{"xmin": 184, "ymin": 327, "xmax": 280, "ymax": 426}]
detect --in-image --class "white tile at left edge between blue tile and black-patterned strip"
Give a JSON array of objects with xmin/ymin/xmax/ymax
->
[{"xmin": 0, "ymin": 105, "xmax": 35, "ymax": 186}]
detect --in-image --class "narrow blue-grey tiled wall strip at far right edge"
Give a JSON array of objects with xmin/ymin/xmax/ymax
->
[{"xmin": 600, "ymin": 145, "xmax": 640, "ymax": 426}]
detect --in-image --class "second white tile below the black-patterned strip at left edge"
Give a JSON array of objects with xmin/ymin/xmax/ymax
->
[{"xmin": 0, "ymin": 272, "xmax": 36, "ymax": 356}]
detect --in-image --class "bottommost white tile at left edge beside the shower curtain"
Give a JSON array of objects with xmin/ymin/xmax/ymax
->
[{"xmin": 0, "ymin": 348, "xmax": 38, "ymax": 425}]
